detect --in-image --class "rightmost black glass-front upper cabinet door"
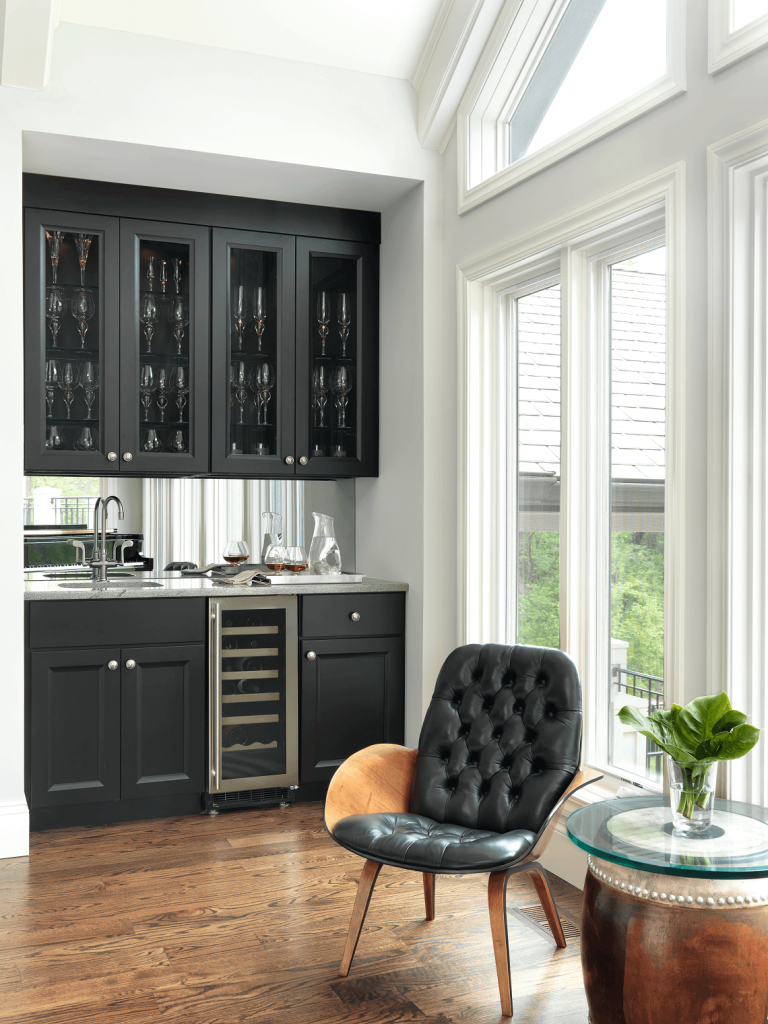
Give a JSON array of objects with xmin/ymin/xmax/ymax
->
[{"xmin": 296, "ymin": 238, "xmax": 379, "ymax": 477}]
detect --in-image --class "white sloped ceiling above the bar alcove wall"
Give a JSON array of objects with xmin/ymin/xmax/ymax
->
[{"xmin": 60, "ymin": 0, "xmax": 441, "ymax": 79}]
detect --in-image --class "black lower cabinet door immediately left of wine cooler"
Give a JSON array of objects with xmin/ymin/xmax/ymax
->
[{"xmin": 121, "ymin": 644, "xmax": 206, "ymax": 800}]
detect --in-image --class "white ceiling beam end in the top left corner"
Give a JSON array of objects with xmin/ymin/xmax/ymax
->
[{"xmin": 0, "ymin": 0, "xmax": 60, "ymax": 90}]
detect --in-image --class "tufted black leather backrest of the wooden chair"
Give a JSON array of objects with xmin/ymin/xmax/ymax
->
[{"xmin": 411, "ymin": 644, "xmax": 582, "ymax": 833}]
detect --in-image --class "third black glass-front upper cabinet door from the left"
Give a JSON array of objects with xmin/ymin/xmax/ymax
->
[{"xmin": 211, "ymin": 228, "xmax": 295, "ymax": 477}]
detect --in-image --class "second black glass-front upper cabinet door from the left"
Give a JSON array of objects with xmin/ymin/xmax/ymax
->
[{"xmin": 120, "ymin": 219, "xmax": 209, "ymax": 475}]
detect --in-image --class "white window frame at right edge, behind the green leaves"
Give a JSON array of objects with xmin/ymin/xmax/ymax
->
[{"xmin": 707, "ymin": 121, "xmax": 768, "ymax": 806}]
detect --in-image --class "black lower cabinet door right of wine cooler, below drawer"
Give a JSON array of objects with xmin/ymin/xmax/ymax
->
[{"xmin": 301, "ymin": 637, "xmax": 404, "ymax": 782}]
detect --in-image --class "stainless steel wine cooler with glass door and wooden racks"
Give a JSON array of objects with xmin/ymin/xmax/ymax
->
[{"xmin": 209, "ymin": 597, "xmax": 299, "ymax": 794}]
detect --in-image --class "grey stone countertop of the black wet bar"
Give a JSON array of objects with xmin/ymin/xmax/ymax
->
[{"xmin": 24, "ymin": 572, "xmax": 408, "ymax": 601}]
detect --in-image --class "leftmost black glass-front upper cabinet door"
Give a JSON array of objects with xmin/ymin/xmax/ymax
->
[{"xmin": 24, "ymin": 210, "xmax": 120, "ymax": 474}]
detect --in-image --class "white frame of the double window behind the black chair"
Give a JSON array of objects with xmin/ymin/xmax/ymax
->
[{"xmin": 458, "ymin": 163, "xmax": 686, "ymax": 790}]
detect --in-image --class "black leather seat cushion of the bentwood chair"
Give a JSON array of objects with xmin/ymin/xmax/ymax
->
[{"xmin": 334, "ymin": 813, "xmax": 536, "ymax": 874}]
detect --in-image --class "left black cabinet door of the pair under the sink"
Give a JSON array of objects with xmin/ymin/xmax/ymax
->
[{"xmin": 29, "ymin": 648, "xmax": 120, "ymax": 808}]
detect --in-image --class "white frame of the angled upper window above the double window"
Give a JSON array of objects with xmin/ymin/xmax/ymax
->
[{"xmin": 457, "ymin": 0, "xmax": 686, "ymax": 213}]
